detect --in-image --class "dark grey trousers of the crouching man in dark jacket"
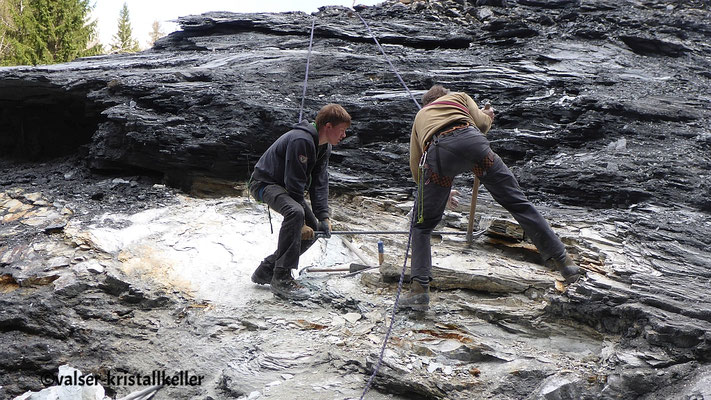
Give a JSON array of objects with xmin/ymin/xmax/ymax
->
[{"xmin": 250, "ymin": 181, "xmax": 318, "ymax": 270}]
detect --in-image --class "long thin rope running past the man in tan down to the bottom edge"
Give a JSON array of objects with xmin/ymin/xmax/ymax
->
[{"xmin": 353, "ymin": 7, "xmax": 422, "ymax": 400}]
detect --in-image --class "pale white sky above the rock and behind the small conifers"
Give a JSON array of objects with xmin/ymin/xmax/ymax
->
[{"xmin": 90, "ymin": 0, "xmax": 390, "ymax": 49}]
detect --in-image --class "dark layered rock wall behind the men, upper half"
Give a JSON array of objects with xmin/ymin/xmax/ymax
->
[{"xmin": 0, "ymin": 1, "xmax": 711, "ymax": 206}]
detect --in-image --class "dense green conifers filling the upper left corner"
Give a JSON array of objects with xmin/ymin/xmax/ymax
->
[{"xmin": 0, "ymin": 0, "xmax": 103, "ymax": 65}]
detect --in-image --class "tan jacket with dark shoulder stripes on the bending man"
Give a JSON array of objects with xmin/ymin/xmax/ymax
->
[{"xmin": 410, "ymin": 92, "xmax": 491, "ymax": 182}]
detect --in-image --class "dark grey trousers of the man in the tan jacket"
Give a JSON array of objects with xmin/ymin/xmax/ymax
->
[{"xmin": 411, "ymin": 127, "xmax": 565, "ymax": 283}]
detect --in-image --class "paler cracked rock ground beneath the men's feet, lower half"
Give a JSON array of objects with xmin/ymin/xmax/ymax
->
[{"xmin": 0, "ymin": 155, "xmax": 710, "ymax": 399}]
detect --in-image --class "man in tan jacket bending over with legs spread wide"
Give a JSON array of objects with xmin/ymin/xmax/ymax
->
[{"xmin": 400, "ymin": 85, "xmax": 580, "ymax": 311}]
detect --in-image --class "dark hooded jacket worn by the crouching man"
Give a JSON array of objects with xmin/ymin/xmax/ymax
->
[{"xmin": 252, "ymin": 121, "xmax": 331, "ymax": 220}]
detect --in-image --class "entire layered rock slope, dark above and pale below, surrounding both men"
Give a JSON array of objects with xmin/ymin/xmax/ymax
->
[{"xmin": 0, "ymin": 0, "xmax": 711, "ymax": 399}]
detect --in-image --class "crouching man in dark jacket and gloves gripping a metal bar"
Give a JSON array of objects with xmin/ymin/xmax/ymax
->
[{"xmin": 249, "ymin": 104, "xmax": 351, "ymax": 300}]
